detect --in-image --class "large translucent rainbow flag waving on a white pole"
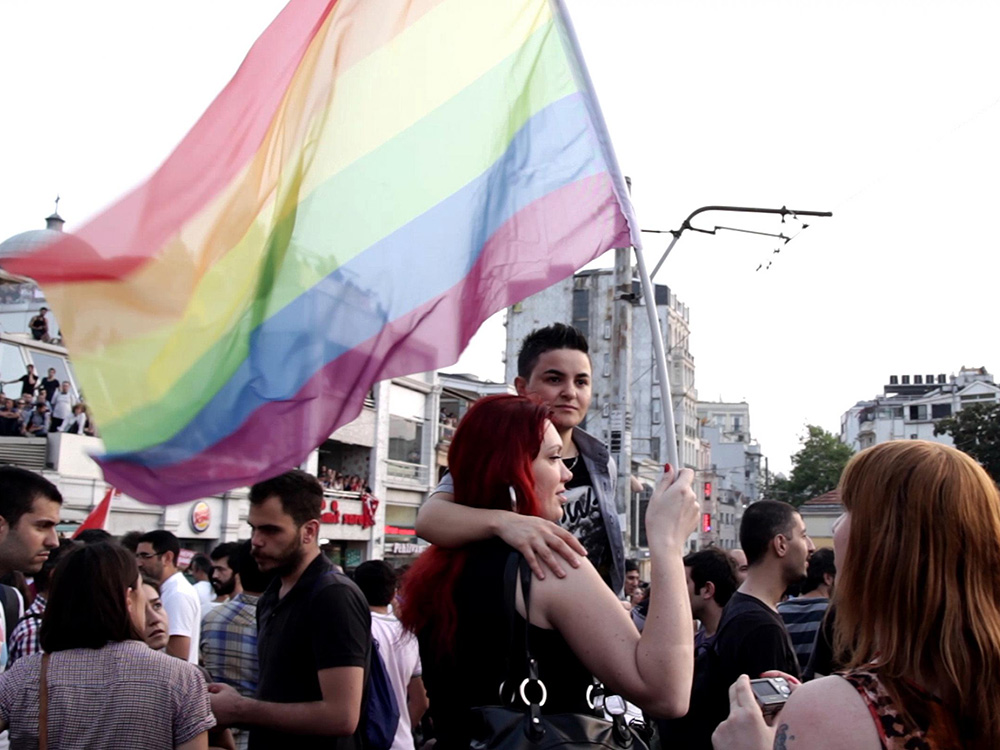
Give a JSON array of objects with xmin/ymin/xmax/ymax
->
[{"xmin": 5, "ymin": 0, "xmax": 639, "ymax": 503}]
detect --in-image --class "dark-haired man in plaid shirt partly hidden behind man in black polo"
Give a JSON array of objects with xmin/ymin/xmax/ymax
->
[{"xmin": 201, "ymin": 541, "xmax": 274, "ymax": 750}]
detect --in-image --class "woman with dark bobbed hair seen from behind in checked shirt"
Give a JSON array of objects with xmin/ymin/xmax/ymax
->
[{"xmin": 0, "ymin": 543, "xmax": 215, "ymax": 750}]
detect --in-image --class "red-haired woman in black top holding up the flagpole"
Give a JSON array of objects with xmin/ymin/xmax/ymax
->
[{"xmin": 398, "ymin": 396, "xmax": 698, "ymax": 750}]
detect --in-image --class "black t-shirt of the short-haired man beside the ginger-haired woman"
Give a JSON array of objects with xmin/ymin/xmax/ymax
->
[{"xmin": 659, "ymin": 592, "xmax": 799, "ymax": 750}]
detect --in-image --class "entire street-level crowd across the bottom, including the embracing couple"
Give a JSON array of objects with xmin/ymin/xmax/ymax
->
[{"xmin": 0, "ymin": 326, "xmax": 1000, "ymax": 750}]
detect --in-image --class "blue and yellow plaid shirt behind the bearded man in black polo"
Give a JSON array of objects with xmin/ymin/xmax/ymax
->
[{"xmin": 201, "ymin": 594, "xmax": 259, "ymax": 697}]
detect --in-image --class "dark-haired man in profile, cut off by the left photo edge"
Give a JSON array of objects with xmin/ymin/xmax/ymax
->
[{"xmin": 0, "ymin": 466, "xmax": 62, "ymax": 672}]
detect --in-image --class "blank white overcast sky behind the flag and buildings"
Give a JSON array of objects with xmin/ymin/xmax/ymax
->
[{"xmin": 0, "ymin": 0, "xmax": 1000, "ymax": 470}]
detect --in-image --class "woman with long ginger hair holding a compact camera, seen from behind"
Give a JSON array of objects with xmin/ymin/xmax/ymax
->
[{"xmin": 713, "ymin": 440, "xmax": 1000, "ymax": 750}]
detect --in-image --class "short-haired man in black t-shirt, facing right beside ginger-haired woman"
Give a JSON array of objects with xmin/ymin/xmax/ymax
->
[{"xmin": 672, "ymin": 500, "xmax": 816, "ymax": 750}]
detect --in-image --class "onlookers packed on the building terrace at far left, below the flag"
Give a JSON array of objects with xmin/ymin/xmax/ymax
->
[{"xmin": 0, "ymin": 365, "xmax": 96, "ymax": 437}]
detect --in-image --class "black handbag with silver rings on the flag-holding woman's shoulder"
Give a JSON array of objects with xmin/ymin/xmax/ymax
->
[{"xmin": 469, "ymin": 552, "xmax": 649, "ymax": 750}]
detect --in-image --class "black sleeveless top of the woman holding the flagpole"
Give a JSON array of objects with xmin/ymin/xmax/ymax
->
[{"xmin": 418, "ymin": 539, "xmax": 592, "ymax": 750}]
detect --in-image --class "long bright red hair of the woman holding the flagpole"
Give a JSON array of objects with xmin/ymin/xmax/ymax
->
[{"xmin": 396, "ymin": 395, "xmax": 549, "ymax": 654}]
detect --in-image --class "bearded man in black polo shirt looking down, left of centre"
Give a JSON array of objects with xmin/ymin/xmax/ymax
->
[{"xmin": 209, "ymin": 469, "xmax": 371, "ymax": 750}]
